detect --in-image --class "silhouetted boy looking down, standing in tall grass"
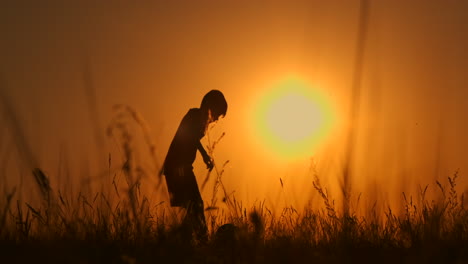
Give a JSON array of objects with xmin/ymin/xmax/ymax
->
[{"xmin": 163, "ymin": 90, "xmax": 227, "ymax": 239}]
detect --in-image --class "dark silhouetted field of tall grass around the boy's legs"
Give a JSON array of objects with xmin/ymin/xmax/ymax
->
[{"xmin": 0, "ymin": 106, "xmax": 468, "ymax": 263}]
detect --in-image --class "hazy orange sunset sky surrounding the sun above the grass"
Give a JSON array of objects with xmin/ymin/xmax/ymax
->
[{"xmin": 0, "ymin": 0, "xmax": 468, "ymax": 214}]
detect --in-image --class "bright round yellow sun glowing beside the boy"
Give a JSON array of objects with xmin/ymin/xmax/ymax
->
[{"xmin": 253, "ymin": 78, "xmax": 335, "ymax": 158}]
